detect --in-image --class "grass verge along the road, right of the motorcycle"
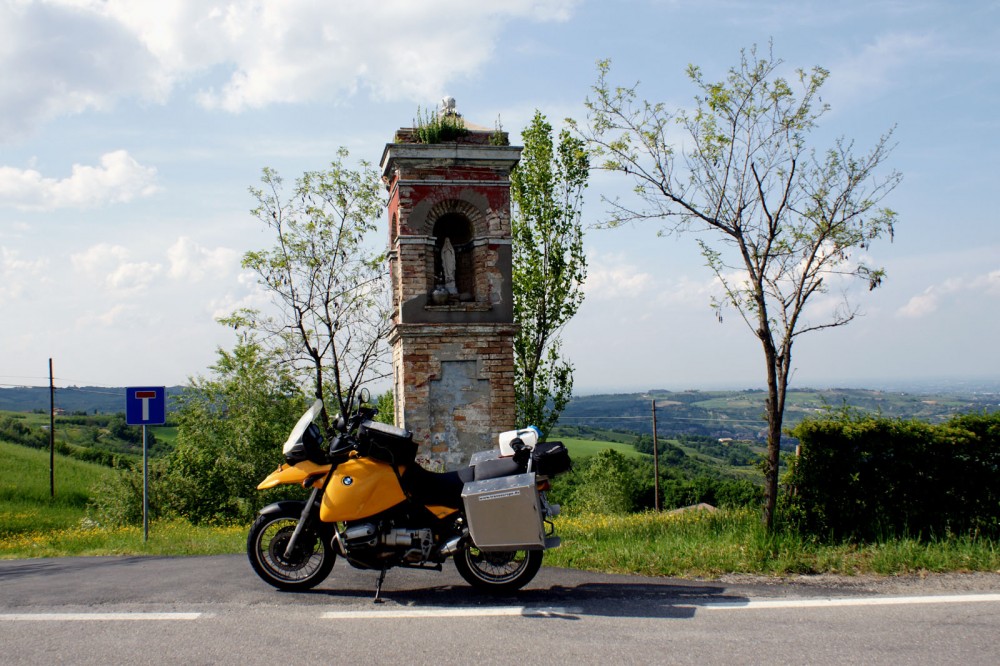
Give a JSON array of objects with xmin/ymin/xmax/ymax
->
[{"xmin": 545, "ymin": 510, "xmax": 1000, "ymax": 578}]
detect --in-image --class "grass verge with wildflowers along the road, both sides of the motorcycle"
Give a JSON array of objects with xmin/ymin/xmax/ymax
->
[{"xmin": 0, "ymin": 511, "xmax": 1000, "ymax": 578}]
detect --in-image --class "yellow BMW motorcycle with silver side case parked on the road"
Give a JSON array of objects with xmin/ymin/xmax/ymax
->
[{"xmin": 247, "ymin": 391, "xmax": 570, "ymax": 601}]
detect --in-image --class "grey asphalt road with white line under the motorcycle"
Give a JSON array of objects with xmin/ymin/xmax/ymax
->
[{"xmin": 0, "ymin": 556, "xmax": 1000, "ymax": 665}]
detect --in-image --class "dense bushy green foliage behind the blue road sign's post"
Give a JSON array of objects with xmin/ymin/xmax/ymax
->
[{"xmin": 93, "ymin": 337, "xmax": 306, "ymax": 524}]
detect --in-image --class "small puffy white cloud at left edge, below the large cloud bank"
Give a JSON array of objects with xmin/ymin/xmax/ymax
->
[{"xmin": 0, "ymin": 150, "xmax": 157, "ymax": 210}]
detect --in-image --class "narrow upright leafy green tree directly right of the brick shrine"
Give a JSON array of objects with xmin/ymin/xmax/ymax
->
[{"xmin": 511, "ymin": 111, "xmax": 590, "ymax": 433}]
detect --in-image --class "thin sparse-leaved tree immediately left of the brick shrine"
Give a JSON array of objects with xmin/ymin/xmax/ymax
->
[{"xmin": 223, "ymin": 148, "xmax": 390, "ymax": 431}]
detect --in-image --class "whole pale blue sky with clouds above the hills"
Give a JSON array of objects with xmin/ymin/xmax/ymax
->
[{"xmin": 0, "ymin": 0, "xmax": 1000, "ymax": 392}]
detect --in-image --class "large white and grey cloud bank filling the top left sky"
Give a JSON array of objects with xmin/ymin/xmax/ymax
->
[{"xmin": 0, "ymin": 0, "xmax": 576, "ymax": 131}]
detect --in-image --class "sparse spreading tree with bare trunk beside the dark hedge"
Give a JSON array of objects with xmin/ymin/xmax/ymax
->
[{"xmin": 580, "ymin": 48, "xmax": 901, "ymax": 529}]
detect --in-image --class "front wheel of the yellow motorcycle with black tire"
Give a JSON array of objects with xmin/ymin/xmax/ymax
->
[{"xmin": 247, "ymin": 508, "xmax": 337, "ymax": 590}]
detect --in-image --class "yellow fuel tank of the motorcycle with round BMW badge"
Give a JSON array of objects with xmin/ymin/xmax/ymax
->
[{"xmin": 319, "ymin": 458, "xmax": 406, "ymax": 523}]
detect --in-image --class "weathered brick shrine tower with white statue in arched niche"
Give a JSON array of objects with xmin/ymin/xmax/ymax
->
[{"xmin": 382, "ymin": 115, "xmax": 521, "ymax": 469}]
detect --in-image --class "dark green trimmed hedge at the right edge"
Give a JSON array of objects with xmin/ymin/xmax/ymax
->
[{"xmin": 786, "ymin": 411, "xmax": 1000, "ymax": 539}]
